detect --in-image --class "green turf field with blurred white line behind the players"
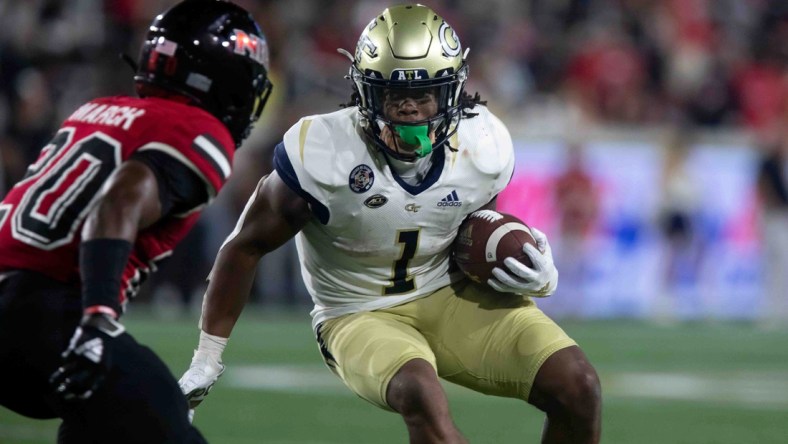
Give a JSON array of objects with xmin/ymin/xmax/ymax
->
[{"xmin": 0, "ymin": 310, "xmax": 788, "ymax": 444}]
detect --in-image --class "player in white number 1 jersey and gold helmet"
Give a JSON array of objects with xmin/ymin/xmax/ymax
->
[{"xmin": 180, "ymin": 5, "xmax": 601, "ymax": 443}]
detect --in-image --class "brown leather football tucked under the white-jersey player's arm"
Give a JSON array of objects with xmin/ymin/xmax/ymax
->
[{"xmin": 452, "ymin": 210, "xmax": 536, "ymax": 282}]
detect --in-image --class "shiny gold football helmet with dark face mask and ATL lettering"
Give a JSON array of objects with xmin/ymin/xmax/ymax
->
[{"xmin": 340, "ymin": 4, "xmax": 468, "ymax": 157}]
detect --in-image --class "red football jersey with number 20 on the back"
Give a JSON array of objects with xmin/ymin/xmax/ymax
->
[{"xmin": 0, "ymin": 96, "xmax": 235, "ymax": 303}]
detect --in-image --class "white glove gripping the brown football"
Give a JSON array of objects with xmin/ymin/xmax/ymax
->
[{"xmin": 487, "ymin": 227, "xmax": 558, "ymax": 298}]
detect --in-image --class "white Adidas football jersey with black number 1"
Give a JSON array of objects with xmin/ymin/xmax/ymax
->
[{"xmin": 274, "ymin": 106, "xmax": 514, "ymax": 326}]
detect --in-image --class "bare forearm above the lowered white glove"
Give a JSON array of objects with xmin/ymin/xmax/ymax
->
[{"xmin": 201, "ymin": 244, "xmax": 260, "ymax": 338}]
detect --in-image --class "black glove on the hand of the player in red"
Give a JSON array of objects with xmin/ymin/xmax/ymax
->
[{"xmin": 49, "ymin": 313, "xmax": 126, "ymax": 401}]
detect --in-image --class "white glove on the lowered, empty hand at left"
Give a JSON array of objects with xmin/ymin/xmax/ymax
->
[{"xmin": 178, "ymin": 332, "xmax": 227, "ymax": 408}]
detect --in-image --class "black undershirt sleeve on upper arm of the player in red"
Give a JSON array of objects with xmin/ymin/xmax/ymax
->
[{"xmin": 131, "ymin": 150, "xmax": 208, "ymax": 216}]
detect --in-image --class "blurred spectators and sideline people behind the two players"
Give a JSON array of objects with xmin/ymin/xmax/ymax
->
[{"xmin": 0, "ymin": 0, "xmax": 788, "ymax": 319}]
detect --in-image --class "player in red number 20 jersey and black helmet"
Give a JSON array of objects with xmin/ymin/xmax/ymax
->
[{"xmin": 0, "ymin": 0, "xmax": 271, "ymax": 443}]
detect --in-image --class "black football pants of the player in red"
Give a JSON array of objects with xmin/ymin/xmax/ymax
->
[{"xmin": 0, "ymin": 271, "xmax": 205, "ymax": 444}]
